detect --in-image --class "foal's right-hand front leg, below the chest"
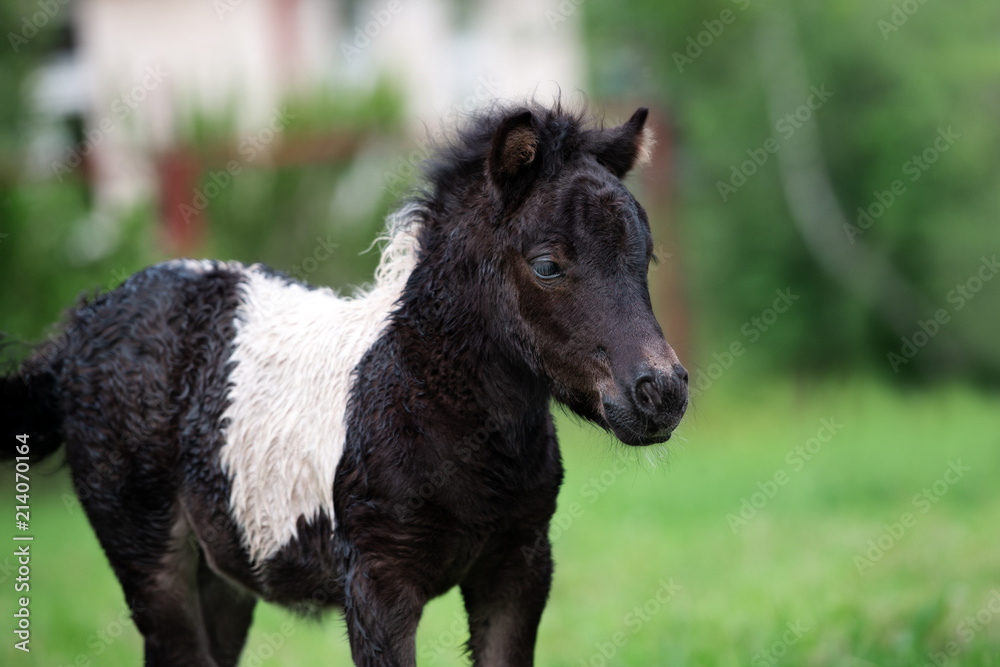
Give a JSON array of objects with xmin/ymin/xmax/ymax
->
[{"xmin": 462, "ymin": 532, "xmax": 552, "ymax": 667}]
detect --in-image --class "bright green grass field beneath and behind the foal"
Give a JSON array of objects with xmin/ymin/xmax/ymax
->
[{"xmin": 0, "ymin": 382, "xmax": 1000, "ymax": 667}]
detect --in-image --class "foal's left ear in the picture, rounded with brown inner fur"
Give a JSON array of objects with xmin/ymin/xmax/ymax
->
[{"xmin": 486, "ymin": 111, "xmax": 538, "ymax": 208}]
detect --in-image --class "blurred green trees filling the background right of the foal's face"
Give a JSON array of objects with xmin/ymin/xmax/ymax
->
[{"xmin": 583, "ymin": 0, "xmax": 1000, "ymax": 380}]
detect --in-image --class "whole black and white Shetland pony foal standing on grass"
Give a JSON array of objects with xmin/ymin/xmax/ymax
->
[{"xmin": 0, "ymin": 106, "xmax": 687, "ymax": 666}]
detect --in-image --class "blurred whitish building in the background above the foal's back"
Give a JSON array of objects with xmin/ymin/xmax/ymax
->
[{"xmin": 33, "ymin": 0, "xmax": 583, "ymax": 210}]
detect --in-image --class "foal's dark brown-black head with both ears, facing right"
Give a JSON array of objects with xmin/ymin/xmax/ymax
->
[{"xmin": 468, "ymin": 108, "xmax": 688, "ymax": 445}]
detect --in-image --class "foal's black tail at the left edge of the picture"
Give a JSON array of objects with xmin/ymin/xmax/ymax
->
[{"xmin": 0, "ymin": 335, "xmax": 63, "ymax": 463}]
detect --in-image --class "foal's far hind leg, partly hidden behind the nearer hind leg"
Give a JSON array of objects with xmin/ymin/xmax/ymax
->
[{"xmin": 198, "ymin": 554, "xmax": 257, "ymax": 667}]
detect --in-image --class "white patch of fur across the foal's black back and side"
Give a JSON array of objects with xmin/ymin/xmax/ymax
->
[{"xmin": 220, "ymin": 213, "xmax": 418, "ymax": 565}]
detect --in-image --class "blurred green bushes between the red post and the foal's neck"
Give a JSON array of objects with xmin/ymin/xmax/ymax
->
[{"xmin": 180, "ymin": 81, "xmax": 403, "ymax": 291}]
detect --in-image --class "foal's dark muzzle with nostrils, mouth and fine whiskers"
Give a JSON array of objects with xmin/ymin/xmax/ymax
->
[{"xmin": 603, "ymin": 364, "xmax": 688, "ymax": 446}]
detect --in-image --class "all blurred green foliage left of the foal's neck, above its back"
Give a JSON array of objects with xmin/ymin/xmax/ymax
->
[{"xmin": 0, "ymin": 5, "xmax": 402, "ymax": 344}]
